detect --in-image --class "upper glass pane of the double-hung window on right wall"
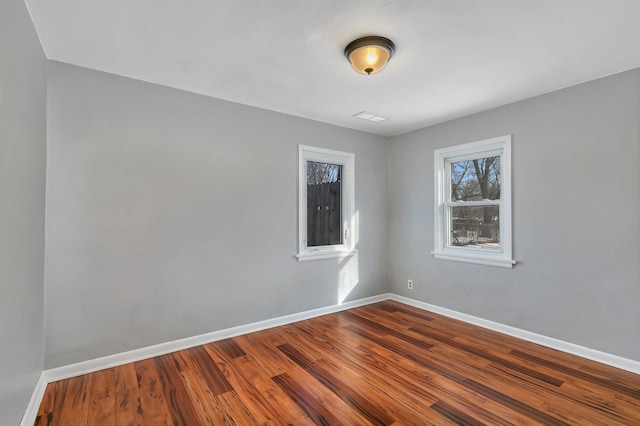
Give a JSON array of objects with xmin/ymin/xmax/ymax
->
[{"xmin": 451, "ymin": 156, "xmax": 500, "ymax": 201}]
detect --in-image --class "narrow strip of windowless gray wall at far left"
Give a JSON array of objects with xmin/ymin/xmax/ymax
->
[{"xmin": 0, "ymin": 0, "xmax": 47, "ymax": 425}]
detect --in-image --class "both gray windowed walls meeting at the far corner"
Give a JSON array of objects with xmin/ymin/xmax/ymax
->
[{"xmin": 38, "ymin": 55, "xmax": 640, "ymax": 368}]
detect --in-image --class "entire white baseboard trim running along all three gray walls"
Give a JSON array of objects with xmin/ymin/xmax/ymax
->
[{"xmin": 20, "ymin": 293, "xmax": 640, "ymax": 426}]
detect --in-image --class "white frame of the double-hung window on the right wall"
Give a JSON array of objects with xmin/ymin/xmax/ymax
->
[{"xmin": 431, "ymin": 135, "xmax": 516, "ymax": 268}]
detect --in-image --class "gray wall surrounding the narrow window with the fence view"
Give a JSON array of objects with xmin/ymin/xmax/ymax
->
[{"xmin": 45, "ymin": 62, "xmax": 388, "ymax": 368}]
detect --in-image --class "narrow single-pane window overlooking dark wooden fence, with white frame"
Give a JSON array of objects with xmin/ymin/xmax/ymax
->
[{"xmin": 297, "ymin": 145, "xmax": 355, "ymax": 261}]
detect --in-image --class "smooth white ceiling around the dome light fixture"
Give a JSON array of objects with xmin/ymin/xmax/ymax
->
[{"xmin": 26, "ymin": 0, "xmax": 640, "ymax": 136}]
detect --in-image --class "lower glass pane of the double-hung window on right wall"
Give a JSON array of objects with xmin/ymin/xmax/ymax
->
[{"xmin": 449, "ymin": 206, "xmax": 500, "ymax": 250}]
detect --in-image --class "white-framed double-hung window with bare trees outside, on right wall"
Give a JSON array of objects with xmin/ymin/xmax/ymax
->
[{"xmin": 433, "ymin": 135, "xmax": 516, "ymax": 268}]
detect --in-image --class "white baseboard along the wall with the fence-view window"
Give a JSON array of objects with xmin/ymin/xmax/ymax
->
[{"xmin": 44, "ymin": 294, "xmax": 390, "ymax": 383}]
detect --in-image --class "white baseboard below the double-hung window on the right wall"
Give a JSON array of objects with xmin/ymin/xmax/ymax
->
[{"xmin": 389, "ymin": 294, "xmax": 640, "ymax": 374}]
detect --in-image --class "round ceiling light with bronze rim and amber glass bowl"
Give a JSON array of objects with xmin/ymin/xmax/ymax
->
[{"xmin": 344, "ymin": 36, "xmax": 396, "ymax": 75}]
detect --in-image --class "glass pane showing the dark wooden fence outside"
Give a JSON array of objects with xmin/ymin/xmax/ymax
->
[{"xmin": 307, "ymin": 161, "xmax": 343, "ymax": 247}]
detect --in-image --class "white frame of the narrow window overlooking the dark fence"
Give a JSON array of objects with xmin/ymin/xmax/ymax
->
[{"xmin": 296, "ymin": 145, "xmax": 357, "ymax": 262}]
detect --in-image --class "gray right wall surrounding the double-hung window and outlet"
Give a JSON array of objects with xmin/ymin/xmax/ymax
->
[{"xmin": 389, "ymin": 69, "xmax": 640, "ymax": 361}]
